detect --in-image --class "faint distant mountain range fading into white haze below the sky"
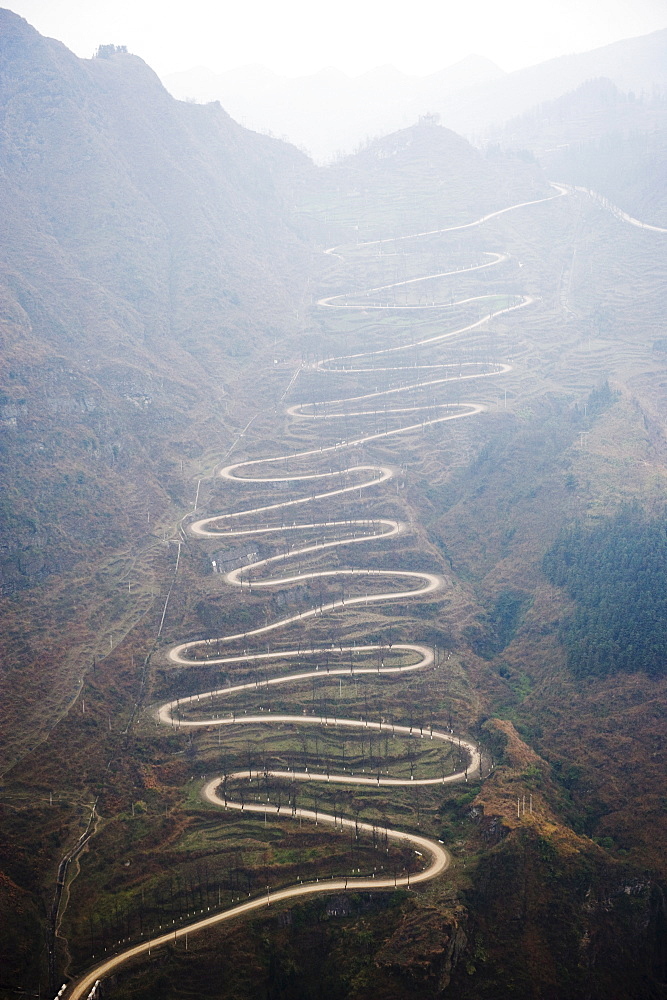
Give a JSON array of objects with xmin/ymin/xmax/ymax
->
[{"xmin": 163, "ymin": 29, "xmax": 667, "ymax": 162}]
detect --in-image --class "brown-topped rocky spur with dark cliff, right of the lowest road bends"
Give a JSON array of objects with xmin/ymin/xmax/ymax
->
[{"xmin": 446, "ymin": 719, "xmax": 665, "ymax": 1000}]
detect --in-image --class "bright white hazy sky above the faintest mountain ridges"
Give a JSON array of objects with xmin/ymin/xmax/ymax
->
[{"xmin": 6, "ymin": 0, "xmax": 667, "ymax": 76}]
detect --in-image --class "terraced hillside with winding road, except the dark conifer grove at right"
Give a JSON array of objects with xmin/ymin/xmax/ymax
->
[{"xmin": 0, "ymin": 13, "xmax": 665, "ymax": 1000}]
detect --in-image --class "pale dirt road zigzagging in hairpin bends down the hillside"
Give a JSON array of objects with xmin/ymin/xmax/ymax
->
[{"xmin": 66, "ymin": 185, "xmax": 567, "ymax": 1000}]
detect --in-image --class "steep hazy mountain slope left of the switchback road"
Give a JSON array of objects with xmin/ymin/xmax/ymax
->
[{"xmin": 0, "ymin": 5, "xmax": 318, "ymax": 764}]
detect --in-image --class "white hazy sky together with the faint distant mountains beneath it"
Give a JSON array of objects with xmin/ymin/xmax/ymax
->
[{"xmin": 6, "ymin": 0, "xmax": 667, "ymax": 162}]
